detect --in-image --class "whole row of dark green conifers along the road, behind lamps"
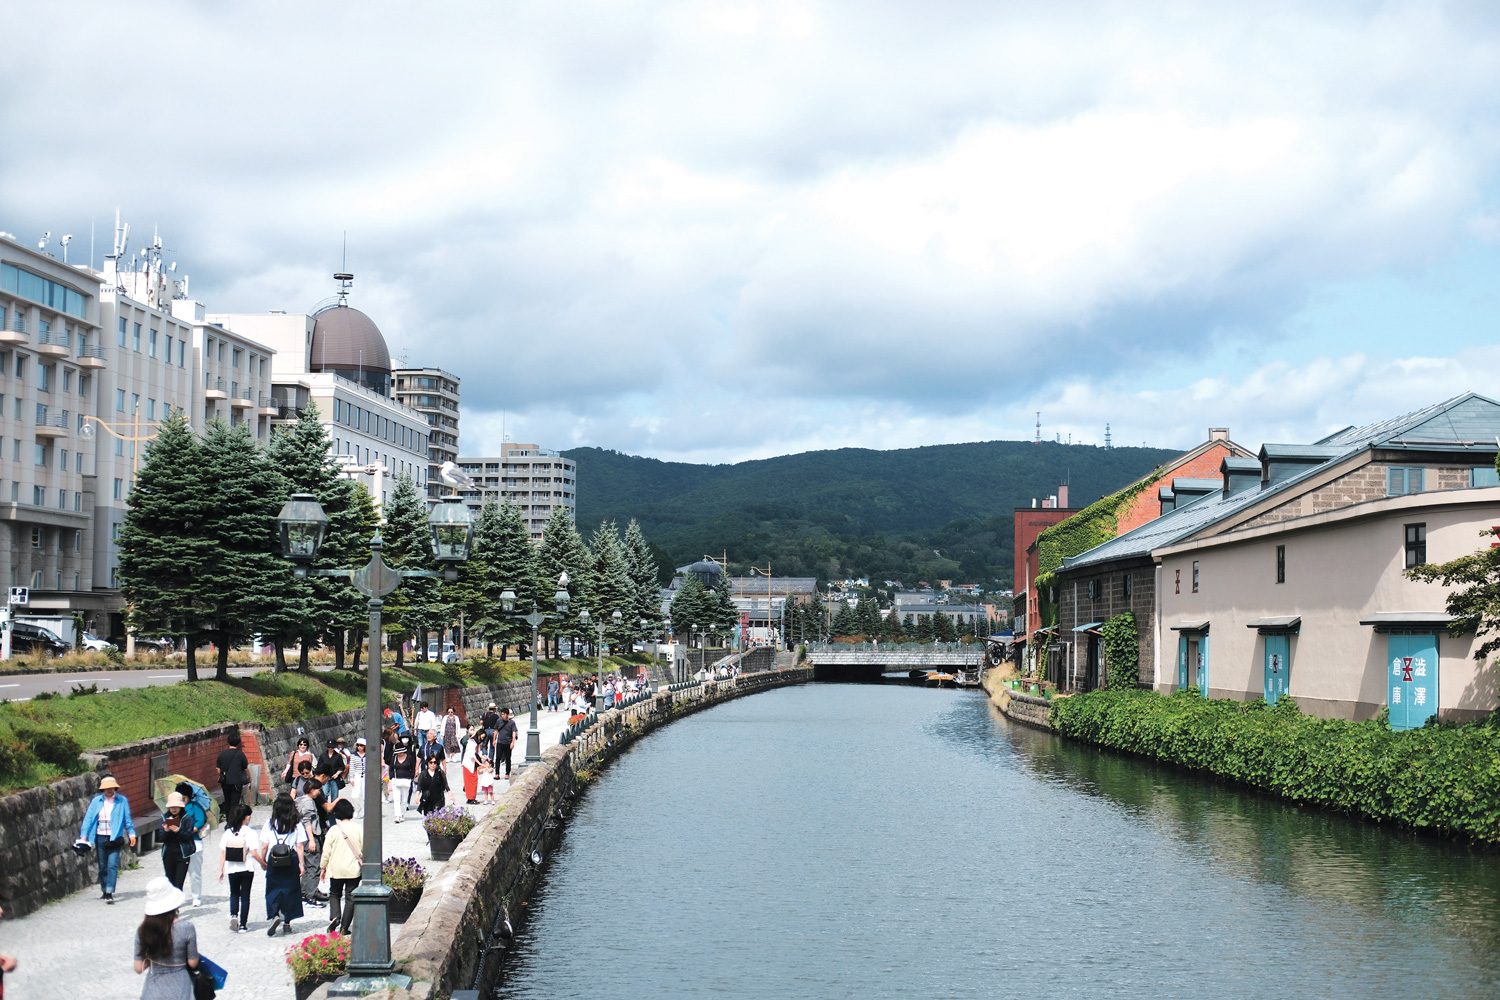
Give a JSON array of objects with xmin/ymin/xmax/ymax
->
[{"xmin": 119, "ymin": 409, "xmax": 662, "ymax": 681}]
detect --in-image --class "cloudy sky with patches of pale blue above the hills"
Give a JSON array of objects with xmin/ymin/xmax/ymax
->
[{"xmin": 0, "ymin": 0, "xmax": 1500, "ymax": 462}]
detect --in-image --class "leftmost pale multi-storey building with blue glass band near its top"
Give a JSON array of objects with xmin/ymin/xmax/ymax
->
[{"xmin": 0, "ymin": 234, "xmax": 104, "ymax": 613}]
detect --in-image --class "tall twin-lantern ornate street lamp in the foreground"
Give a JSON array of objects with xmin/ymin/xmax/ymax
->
[{"xmin": 276, "ymin": 493, "xmax": 474, "ymax": 997}]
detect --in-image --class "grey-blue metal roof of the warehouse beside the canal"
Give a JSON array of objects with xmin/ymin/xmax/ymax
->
[{"xmin": 1061, "ymin": 393, "xmax": 1500, "ymax": 570}]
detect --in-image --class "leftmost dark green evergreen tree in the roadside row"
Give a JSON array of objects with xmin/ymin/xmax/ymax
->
[{"xmin": 119, "ymin": 411, "xmax": 215, "ymax": 681}]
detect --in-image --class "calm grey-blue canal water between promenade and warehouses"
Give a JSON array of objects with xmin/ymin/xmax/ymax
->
[{"xmin": 497, "ymin": 684, "xmax": 1500, "ymax": 1000}]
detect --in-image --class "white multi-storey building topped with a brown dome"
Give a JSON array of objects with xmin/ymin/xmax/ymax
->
[{"xmin": 209, "ymin": 295, "xmax": 429, "ymax": 504}]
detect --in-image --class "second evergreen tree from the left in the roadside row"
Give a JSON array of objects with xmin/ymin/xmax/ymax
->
[{"xmin": 200, "ymin": 420, "xmax": 294, "ymax": 681}]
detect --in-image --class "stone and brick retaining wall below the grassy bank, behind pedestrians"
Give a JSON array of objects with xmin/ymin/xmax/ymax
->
[{"xmin": 0, "ymin": 681, "xmax": 567, "ymax": 916}]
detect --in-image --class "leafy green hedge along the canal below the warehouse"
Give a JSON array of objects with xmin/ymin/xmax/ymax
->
[{"xmin": 1052, "ymin": 688, "xmax": 1500, "ymax": 844}]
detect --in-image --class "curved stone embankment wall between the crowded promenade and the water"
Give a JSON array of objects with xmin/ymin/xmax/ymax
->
[{"xmin": 367, "ymin": 669, "xmax": 812, "ymax": 1000}]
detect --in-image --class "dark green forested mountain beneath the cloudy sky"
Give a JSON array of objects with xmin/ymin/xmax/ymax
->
[{"xmin": 564, "ymin": 441, "xmax": 1179, "ymax": 586}]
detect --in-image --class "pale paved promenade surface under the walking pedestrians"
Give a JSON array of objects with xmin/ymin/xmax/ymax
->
[{"xmin": 0, "ymin": 712, "xmax": 567, "ymax": 1000}]
